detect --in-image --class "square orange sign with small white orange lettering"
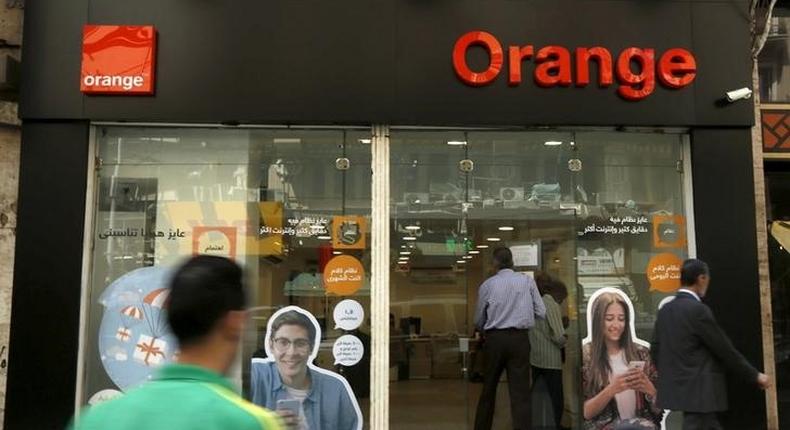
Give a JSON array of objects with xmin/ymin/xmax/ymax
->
[{"xmin": 80, "ymin": 25, "xmax": 156, "ymax": 95}]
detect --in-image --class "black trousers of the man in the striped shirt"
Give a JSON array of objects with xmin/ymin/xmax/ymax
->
[{"xmin": 475, "ymin": 329, "xmax": 532, "ymax": 430}]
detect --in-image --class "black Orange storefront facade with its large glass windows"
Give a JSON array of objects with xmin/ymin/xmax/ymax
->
[{"xmin": 5, "ymin": 0, "xmax": 773, "ymax": 429}]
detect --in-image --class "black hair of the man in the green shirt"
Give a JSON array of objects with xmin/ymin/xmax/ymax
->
[{"xmin": 167, "ymin": 255, "xmax": 246, "ymax": 346}]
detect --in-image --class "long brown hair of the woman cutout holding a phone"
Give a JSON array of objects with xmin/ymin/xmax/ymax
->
[{"xmin": 590, "ymin": 293, "xmax": 638, "ymax": 392}]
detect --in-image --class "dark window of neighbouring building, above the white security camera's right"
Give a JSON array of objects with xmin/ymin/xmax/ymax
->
[{"xmin": 758, "ymin": 7, "xmax": 790, "ymax": 103}]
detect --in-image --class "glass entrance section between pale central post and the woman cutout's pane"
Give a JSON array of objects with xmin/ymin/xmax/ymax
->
[{"xmin": 390, "ymin": 130, "xmax": 581, "ymax": 429}]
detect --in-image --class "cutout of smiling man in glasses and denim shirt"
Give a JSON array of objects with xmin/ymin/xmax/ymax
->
[{"xmin": 251, "ymin": 306, "xmax": 362, "ymax": 430}]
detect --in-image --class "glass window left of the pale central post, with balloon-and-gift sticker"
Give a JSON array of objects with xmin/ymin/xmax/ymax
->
[{"xmin": 81, "ymin": 127, "xmax": 371, "ymax": 428}]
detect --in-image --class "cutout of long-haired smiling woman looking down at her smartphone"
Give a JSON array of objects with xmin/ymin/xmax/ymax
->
[{"xmin": 582, "ymin": 292, "xmax": 663, "ymax": 430}]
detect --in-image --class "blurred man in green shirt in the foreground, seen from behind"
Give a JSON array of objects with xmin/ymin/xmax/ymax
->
[{"xmin": 73, "ymin": 255, "xmax": 282, "ymax": 430}]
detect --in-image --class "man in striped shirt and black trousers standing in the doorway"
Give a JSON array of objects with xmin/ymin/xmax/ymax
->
[{"xmin": 475, "ymin": 248, "xmax": 546, "ymax": 430}]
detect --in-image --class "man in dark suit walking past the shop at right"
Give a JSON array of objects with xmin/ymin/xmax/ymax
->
[{"xmin": 650, "ymin": 259, "xmax": 769, "ymax": 430}]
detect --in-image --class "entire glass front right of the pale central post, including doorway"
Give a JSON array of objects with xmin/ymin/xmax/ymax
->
[{"xmin": 390, "ymin": 130, "xmax": 687, "ymax": 429}]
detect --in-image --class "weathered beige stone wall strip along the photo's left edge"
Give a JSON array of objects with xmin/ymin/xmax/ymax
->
[{"xmin": 0, "ymin": 2, "xmax": 23, "ymax": 430}]
